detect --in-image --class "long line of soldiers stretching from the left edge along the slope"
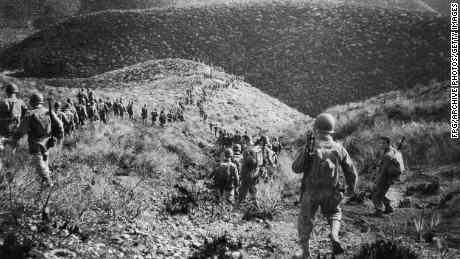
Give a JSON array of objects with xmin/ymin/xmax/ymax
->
[{"xmin": 0, "ymin": 83, "xmax": 190, "ymax": 189}]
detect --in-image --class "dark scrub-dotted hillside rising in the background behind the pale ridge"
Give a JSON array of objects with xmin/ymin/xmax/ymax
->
[{"xmin": 0, "ymin": 1, "xmax": 448, "ymax": 114}]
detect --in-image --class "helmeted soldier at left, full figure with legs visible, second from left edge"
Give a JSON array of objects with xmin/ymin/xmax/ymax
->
[{"xmin": 13, "ymin": 93, "xmax": 64, "ymax": 187}]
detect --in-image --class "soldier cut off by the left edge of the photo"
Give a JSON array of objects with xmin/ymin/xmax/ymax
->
[{"xmin": 0, "ymin": 83, "xmax": 27, "ymax": 138}]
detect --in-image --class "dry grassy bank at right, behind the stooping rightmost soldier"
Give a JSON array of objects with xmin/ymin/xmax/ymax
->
[{"xmin": 327, "ymin": 83, "xmax": 460, "ymax": 172}]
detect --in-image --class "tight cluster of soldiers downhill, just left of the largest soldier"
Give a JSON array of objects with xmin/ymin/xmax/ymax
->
[{"xmin": 209, "ymin": 123, "xmax": 282, "ymax": 207}]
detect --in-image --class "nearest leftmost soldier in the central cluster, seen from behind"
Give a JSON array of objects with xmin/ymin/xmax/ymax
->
[{"xmin": 213, "ymin": 148, "xmax": 239, "ymax": 202}]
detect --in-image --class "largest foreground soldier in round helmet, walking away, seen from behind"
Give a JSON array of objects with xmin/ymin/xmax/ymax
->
[{"xmin": 292, "ymin": 113, "xmax": 358, "ymax": 258}]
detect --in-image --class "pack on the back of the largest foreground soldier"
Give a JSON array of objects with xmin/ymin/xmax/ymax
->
[{"xmin": 308, "ymin": 141, "xmax": 340, "ymax": 189}]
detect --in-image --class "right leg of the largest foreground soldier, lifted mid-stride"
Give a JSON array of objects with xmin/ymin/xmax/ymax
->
[{"xmin": 321, "ymin": 192, "xmax": 344, "ymax": 254}]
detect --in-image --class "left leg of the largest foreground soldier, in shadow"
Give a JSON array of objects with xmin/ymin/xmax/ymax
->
[{"xmin": 297, "ymin": 193, "xmax": 318, "ymax": 258}]
